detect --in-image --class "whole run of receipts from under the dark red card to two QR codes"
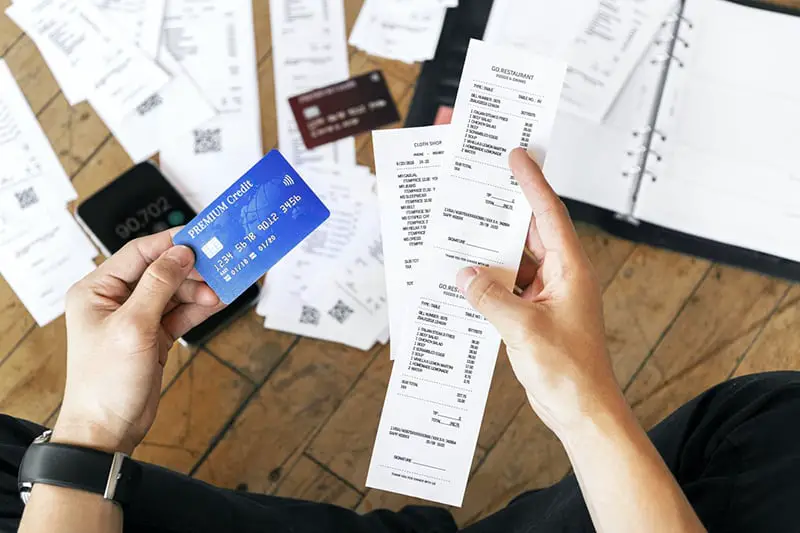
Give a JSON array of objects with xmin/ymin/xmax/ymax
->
[{"xmin": 256, "ymin": 0, "xmax": 389, "ymax": 350}]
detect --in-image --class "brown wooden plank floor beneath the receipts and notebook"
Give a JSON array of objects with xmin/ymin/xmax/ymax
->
[{"xmin": 0, "ymin": 0, "xmax": 800, "ymax": 523}]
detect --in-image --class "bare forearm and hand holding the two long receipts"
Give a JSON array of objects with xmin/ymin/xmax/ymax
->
[{"xmin": 457, "ymin": 149, "xmax": 704, "ymax": 533}]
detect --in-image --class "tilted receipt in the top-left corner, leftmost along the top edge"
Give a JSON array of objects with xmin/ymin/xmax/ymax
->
[{"xmin": 6, "ymin": 0, "xmax": 169, "ymax": 120}]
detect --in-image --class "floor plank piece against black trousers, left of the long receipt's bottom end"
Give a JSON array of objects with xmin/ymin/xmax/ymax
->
[{"xmin": 275, "ymin": 455, "xmax": 361, "ymax": 509}]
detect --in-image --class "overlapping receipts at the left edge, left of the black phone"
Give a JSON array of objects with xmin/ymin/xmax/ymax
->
[{"xmin": 0, "ymin": 60, "xmax": 97, "ymax": 326}]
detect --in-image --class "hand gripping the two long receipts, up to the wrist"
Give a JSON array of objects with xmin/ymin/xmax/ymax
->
[{"xmin": 457, "ymin": 148, "xmax": 622, "ymax": 436}]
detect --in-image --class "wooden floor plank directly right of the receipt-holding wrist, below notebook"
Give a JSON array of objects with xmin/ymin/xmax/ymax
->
[{"xmin": 603, "ymin": 245, "xmax": 710, "ymax": 386}]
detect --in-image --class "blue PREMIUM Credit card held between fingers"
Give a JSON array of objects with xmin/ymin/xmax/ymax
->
[{"xmin": 173, "ymin": 150, "xmax": 330, "ymax": 303}]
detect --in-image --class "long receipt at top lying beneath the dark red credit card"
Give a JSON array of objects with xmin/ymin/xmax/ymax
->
[{"xmin": 270, "ymin": 0, "xmax": 356, "ymax": 166}]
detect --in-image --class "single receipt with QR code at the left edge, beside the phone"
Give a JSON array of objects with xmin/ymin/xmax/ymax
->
[{"xmin": 0, "ymin": 59, "xmax": 78, "ymax": 225}]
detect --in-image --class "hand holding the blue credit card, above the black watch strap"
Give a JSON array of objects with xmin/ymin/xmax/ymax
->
[{"xmin": 53, "ymin": 230, "xmax": 222, "ymax": 454}]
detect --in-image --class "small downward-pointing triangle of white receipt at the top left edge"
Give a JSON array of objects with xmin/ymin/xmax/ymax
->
[{"xmin": 91, "ymin": 0, "xmax": 167, "ymax": 59}]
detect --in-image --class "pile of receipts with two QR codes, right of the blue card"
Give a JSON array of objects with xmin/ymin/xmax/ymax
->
[{"xmin": 256, "ymin": 166, "xmax": 388, "ymax": 350}]
